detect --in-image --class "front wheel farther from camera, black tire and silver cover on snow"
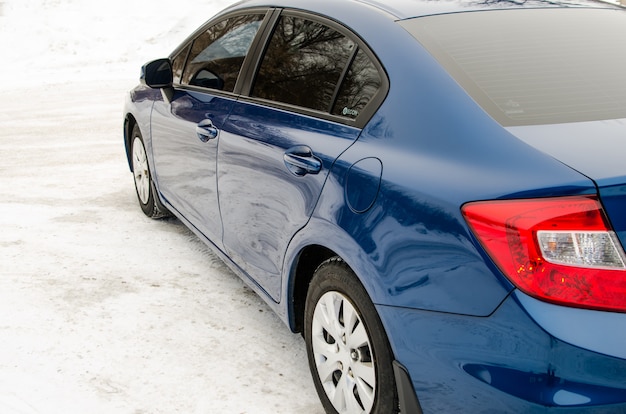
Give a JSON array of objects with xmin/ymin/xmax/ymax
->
[{"xmin": 130, "ymin": 125, "xmax": 170, "ymax": 219}]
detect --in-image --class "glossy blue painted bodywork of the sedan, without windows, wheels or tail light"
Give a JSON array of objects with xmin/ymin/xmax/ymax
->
[{"xmin": 126, "ymin": 0, "xmax": 626, "ymax": 414}]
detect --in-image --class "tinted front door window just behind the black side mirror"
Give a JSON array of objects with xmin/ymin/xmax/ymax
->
[{"xmin": 182, "ymin": 14, "xmax": 264, "ymax": 92}]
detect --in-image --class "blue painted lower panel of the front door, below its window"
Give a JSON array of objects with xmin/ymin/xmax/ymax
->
[{"xmin": 151, "ymin": 91, "xmax": 235, "ymax": 241}]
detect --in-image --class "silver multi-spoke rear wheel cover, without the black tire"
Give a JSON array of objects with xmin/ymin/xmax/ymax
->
[{"xmin": 311, "ymin": 291, "xmax": 376, "ymax": 414}]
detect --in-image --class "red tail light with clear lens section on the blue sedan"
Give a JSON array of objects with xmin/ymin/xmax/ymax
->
[{"xmin": 462, "ymin": 196, "xmax": 626, "ymax": 312}]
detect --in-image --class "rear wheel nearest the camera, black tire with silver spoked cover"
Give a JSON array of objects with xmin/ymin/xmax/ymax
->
[{"xmin": 304, "ymin": 257, "xmax": 398, "ymax": 414}]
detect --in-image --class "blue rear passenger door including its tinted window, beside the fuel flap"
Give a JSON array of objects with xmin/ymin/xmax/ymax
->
[{"xmin": 218, "ymin": 11, "xmax": 381, "ymax": 301}]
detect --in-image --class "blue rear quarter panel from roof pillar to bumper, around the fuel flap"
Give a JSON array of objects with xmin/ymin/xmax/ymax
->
[{"xmin": 280, "ymin": 12, "xmax": 595, "ymax": 316}]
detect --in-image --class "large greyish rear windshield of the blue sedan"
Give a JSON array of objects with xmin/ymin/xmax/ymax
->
[{"xmin": 400, "ymin": 9, "xmax": 626, "ymax": 126}]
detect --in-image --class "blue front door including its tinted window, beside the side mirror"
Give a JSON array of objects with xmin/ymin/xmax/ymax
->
[{"xmin": 152, "ymin": 10, "xmax": 265, "ymax": 246}]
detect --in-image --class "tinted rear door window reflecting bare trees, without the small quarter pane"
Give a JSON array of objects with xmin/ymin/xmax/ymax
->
[{"xmin": 251, "ymin": 15, "xmax": 357, "ymax": 112}]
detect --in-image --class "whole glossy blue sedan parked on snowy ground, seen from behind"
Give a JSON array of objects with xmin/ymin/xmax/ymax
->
[{"xmin": 124, "ymin": 0, "xmax": 626, "ymax": 414}]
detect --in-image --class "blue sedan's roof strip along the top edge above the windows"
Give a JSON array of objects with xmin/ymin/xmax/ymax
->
[{"xmin": 222, "ymin": 0, "xmax": 619, "ymax": 20}]
